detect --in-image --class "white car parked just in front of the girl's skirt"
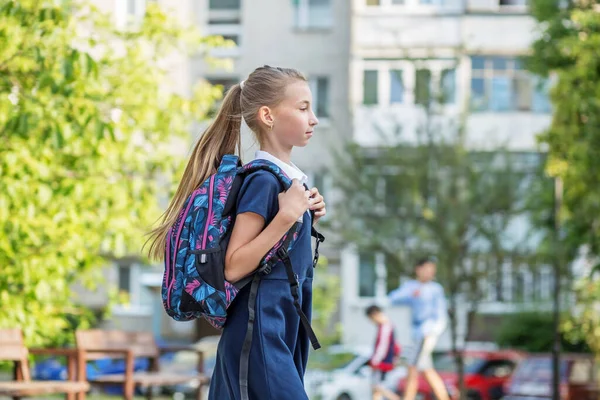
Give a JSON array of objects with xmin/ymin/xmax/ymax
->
[{"xmin": 304, "ymin": 346, "xmax": 406, "ymax": 400}]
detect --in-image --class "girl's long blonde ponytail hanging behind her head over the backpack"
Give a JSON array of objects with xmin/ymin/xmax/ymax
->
[{"xmin": 144, "ymin": 84, "xmax": 242, "ymax": 260}]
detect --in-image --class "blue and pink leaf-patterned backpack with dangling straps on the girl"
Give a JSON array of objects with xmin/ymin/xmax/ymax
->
[{"xmin": 162, "ymin": 155, "xmax": 325, "ymax": 348}]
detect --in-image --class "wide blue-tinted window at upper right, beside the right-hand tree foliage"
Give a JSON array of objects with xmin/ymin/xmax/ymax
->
[{"xmin": 471, "ymin": 56, "xmax": 550, "ymax": 113}]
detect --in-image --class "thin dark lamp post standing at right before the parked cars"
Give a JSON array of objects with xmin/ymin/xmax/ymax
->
[{"xmin": 552, "ymin": 177, "xmax": 563, "ymax": 400}]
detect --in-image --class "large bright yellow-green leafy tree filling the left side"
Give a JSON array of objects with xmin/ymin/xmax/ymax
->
[{"xmin": 0, "ymin": 0, "xmax": 227, "ymax": 345}]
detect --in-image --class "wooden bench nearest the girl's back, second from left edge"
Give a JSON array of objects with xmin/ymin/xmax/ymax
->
[{"xmin": 75, "ymin": 329, "xmax": 208, "ymax": 400}]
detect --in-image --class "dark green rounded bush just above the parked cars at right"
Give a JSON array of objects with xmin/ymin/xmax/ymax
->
[{"xmin": 496, "ymin": 311, "xmax": 589, "ymax": 353}]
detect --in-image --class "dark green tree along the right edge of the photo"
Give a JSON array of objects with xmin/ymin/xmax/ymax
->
[{"xmin": 527, "ymin": 0, "xmax": 600, "ymax": 364}]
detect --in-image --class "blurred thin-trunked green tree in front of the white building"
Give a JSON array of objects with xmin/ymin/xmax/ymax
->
[{"xmin": 333, "ymin": 105, "xmax": 531, "ymax": 393}]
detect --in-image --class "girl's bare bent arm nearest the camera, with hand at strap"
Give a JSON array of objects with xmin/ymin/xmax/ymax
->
[{"xmin": 225, "ymin": 180, "xmax": 309, "ymax": 282}]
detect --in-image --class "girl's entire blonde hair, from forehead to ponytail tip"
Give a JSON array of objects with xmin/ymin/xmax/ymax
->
[{"xmin": 144, "ymin": 65, "xmax": 306, "ymax": 260}]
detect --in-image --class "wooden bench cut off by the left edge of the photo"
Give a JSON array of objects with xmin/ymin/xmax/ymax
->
[{"xmin": 0, "ymin": 329, "xmax": 90, "ymax": 400}]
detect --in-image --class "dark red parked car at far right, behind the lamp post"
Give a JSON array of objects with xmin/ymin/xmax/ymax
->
[{"xmin": 503, "ymin": 354, "xmax": 600, "ymax": 400}]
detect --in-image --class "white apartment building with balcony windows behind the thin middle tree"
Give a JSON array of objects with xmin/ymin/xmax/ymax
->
[{"xmin": 341, "ymin": 0, "xmax": 552, "ymax": 347}]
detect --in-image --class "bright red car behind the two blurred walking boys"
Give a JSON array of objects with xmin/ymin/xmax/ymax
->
[{"xmin": 398, "ymin": 350, "xmax": 525, "ymax": 400}]
